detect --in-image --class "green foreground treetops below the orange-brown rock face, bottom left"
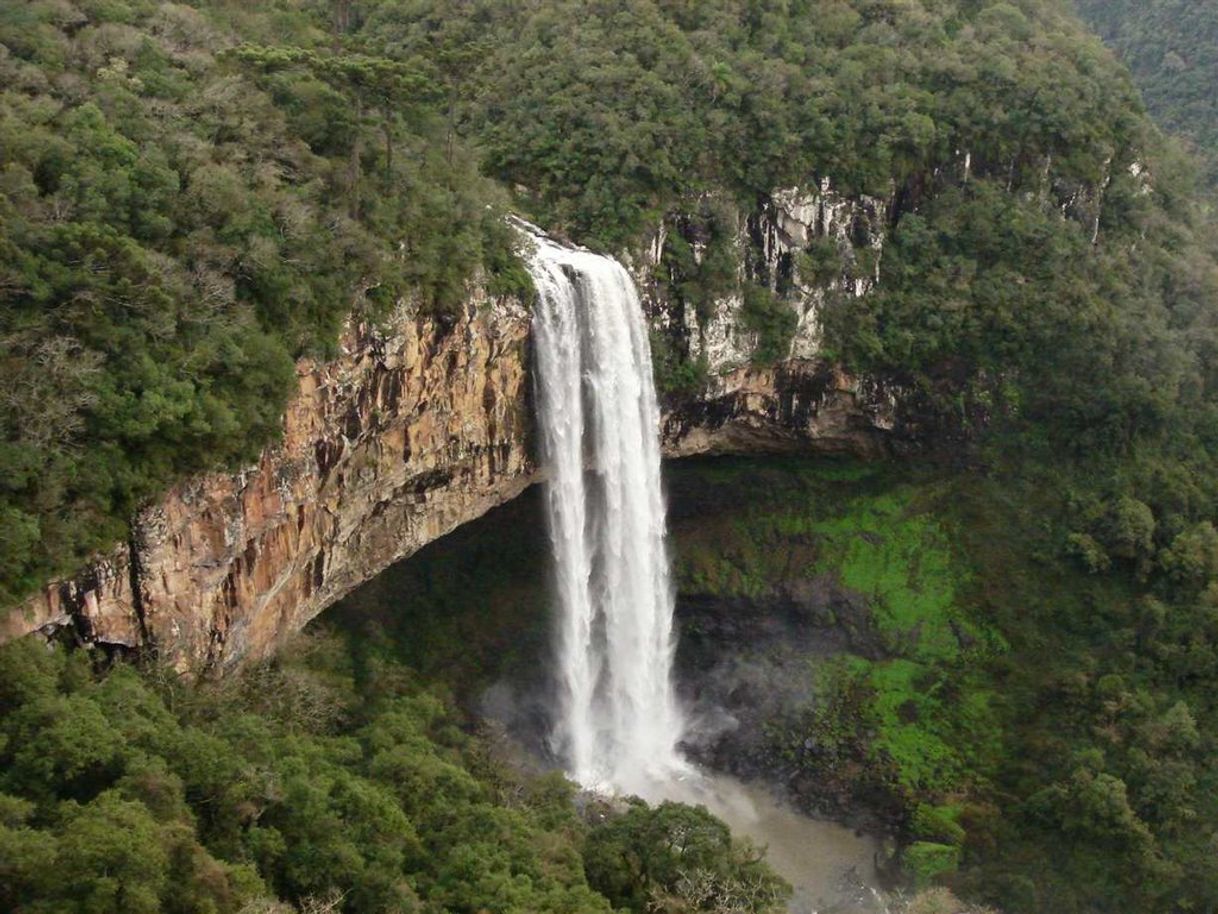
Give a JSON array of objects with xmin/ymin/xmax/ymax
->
[{"xmin": 0, "ymin": 640, "xmax": 787, "ymax": 914}]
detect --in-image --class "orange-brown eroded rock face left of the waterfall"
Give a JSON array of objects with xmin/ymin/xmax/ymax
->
[{"xmin": 0, "ymin": 291, "xmax": 535, "ymax": 673}]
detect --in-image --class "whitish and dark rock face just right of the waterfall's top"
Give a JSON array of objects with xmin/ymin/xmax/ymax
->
[{"xmin": 652, "ymin": 179, "xmax": 907, "ymax": 457}]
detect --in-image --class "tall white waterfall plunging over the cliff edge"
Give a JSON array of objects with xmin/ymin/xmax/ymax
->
[{"xmin": 529, "ymin": 224, "xmax": 682, "ymax": 793}]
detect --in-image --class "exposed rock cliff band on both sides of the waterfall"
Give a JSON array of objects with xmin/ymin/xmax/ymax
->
[{"xmin": 0, "ymin": 196, "xmax": 899, "ymax": 674}]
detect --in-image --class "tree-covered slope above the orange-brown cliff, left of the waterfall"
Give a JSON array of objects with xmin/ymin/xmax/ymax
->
[{"xmin": 0, "ymin": 0, "xmax": 519, "ymax": 603}]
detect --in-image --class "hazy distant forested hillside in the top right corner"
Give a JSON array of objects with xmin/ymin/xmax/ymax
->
[{"xmin": 1075, "ymin": 0, "xmax": 1218, "ymax": 188}]
